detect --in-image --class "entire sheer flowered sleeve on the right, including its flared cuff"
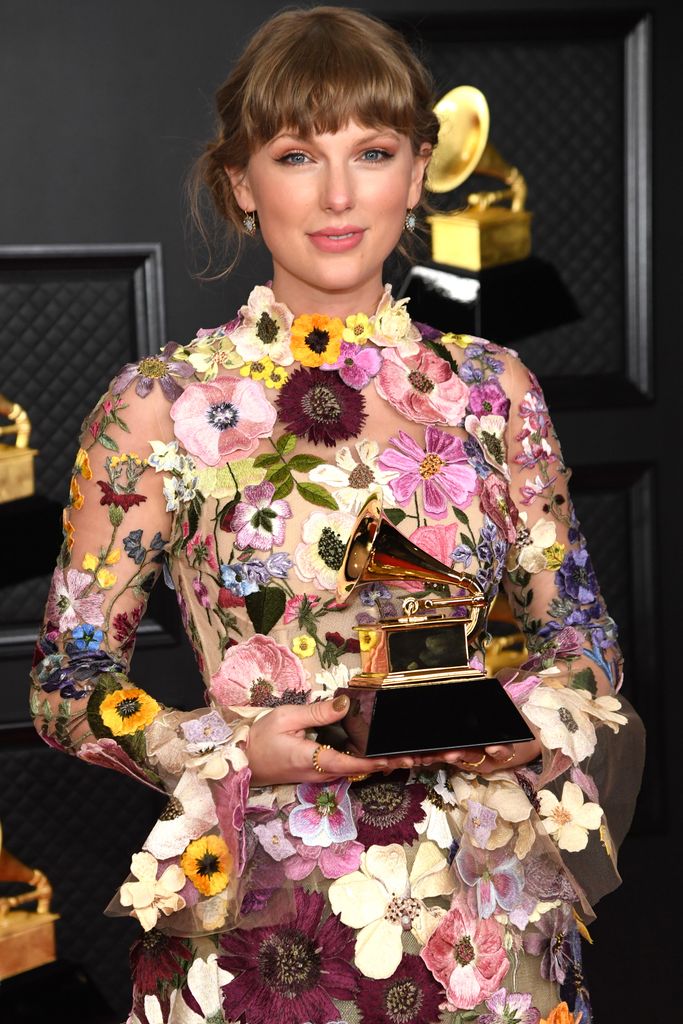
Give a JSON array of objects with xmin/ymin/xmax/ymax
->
[{"xmin": 497, "ymin": 359, "xmax": 644, "ymax": 902}]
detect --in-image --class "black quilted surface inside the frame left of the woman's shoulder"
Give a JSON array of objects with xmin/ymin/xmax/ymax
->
[{"xmin": 0, "ymin": 250, "xmax": 160, "ymax": 627}]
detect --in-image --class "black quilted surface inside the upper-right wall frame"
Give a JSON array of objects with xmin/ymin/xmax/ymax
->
[{"xmin": 411, "ymin": 16, "xmax": 626, "ymax": 378}]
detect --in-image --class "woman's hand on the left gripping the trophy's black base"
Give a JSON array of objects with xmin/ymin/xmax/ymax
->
[{"xmin": 247, "ymin": 695, "xmax": 389, "ymax": 786}]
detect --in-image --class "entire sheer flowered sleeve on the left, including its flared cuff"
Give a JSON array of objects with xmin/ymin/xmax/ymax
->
[{"xmin": 31, "ymin": 362, "xmax": 250, "ymax": 934}]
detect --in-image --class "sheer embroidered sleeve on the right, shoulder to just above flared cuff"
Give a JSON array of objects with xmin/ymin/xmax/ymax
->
[{"xmin": 505, "ymin": 360, "xmax": 622, "ymax": 694}]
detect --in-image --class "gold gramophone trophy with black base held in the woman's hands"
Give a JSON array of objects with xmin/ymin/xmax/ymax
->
[{"xmin": 337, "ymin": 497, "xmax": 533, "ymax": 757}]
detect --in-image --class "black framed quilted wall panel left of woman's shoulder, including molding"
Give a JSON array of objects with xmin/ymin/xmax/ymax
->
[{"xmin": 0, "ymin": 243, "xmax": 177, "ymax": 660}]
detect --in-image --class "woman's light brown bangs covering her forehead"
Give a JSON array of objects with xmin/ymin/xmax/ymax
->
[{"xmin": 242, "ymin": 23, "xmax": 417, "ymax": 152}]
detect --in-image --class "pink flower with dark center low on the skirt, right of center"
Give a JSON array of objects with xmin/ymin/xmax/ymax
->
[{"xmin": 421, "ymin": 904, "xmax": 510, "ymax": 1010}]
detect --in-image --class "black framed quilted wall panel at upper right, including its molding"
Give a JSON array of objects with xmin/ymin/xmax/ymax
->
[{"xmin": 390, "ymin": 8, "xmax": 654, "ymax": 410}]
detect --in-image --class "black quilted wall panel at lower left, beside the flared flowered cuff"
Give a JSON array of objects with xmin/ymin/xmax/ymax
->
[{"xmin": 0, "ymin": 738, "xmax": 164, "ymax": 1024}]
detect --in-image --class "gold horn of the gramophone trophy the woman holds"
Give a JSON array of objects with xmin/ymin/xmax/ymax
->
[{"xmin": 337, "ymin": 495, "xmax": 480, "ymax": 602}]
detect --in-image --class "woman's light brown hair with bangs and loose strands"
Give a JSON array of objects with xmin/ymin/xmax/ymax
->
[{"xmin": 189, "ymin": 7, "xmax": 438, "ymax": 276}]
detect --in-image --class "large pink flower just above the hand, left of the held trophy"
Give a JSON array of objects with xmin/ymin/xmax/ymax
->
[{"xmin": 210, "ymin": 633, "xmax": 310, "ymax": 708}]
